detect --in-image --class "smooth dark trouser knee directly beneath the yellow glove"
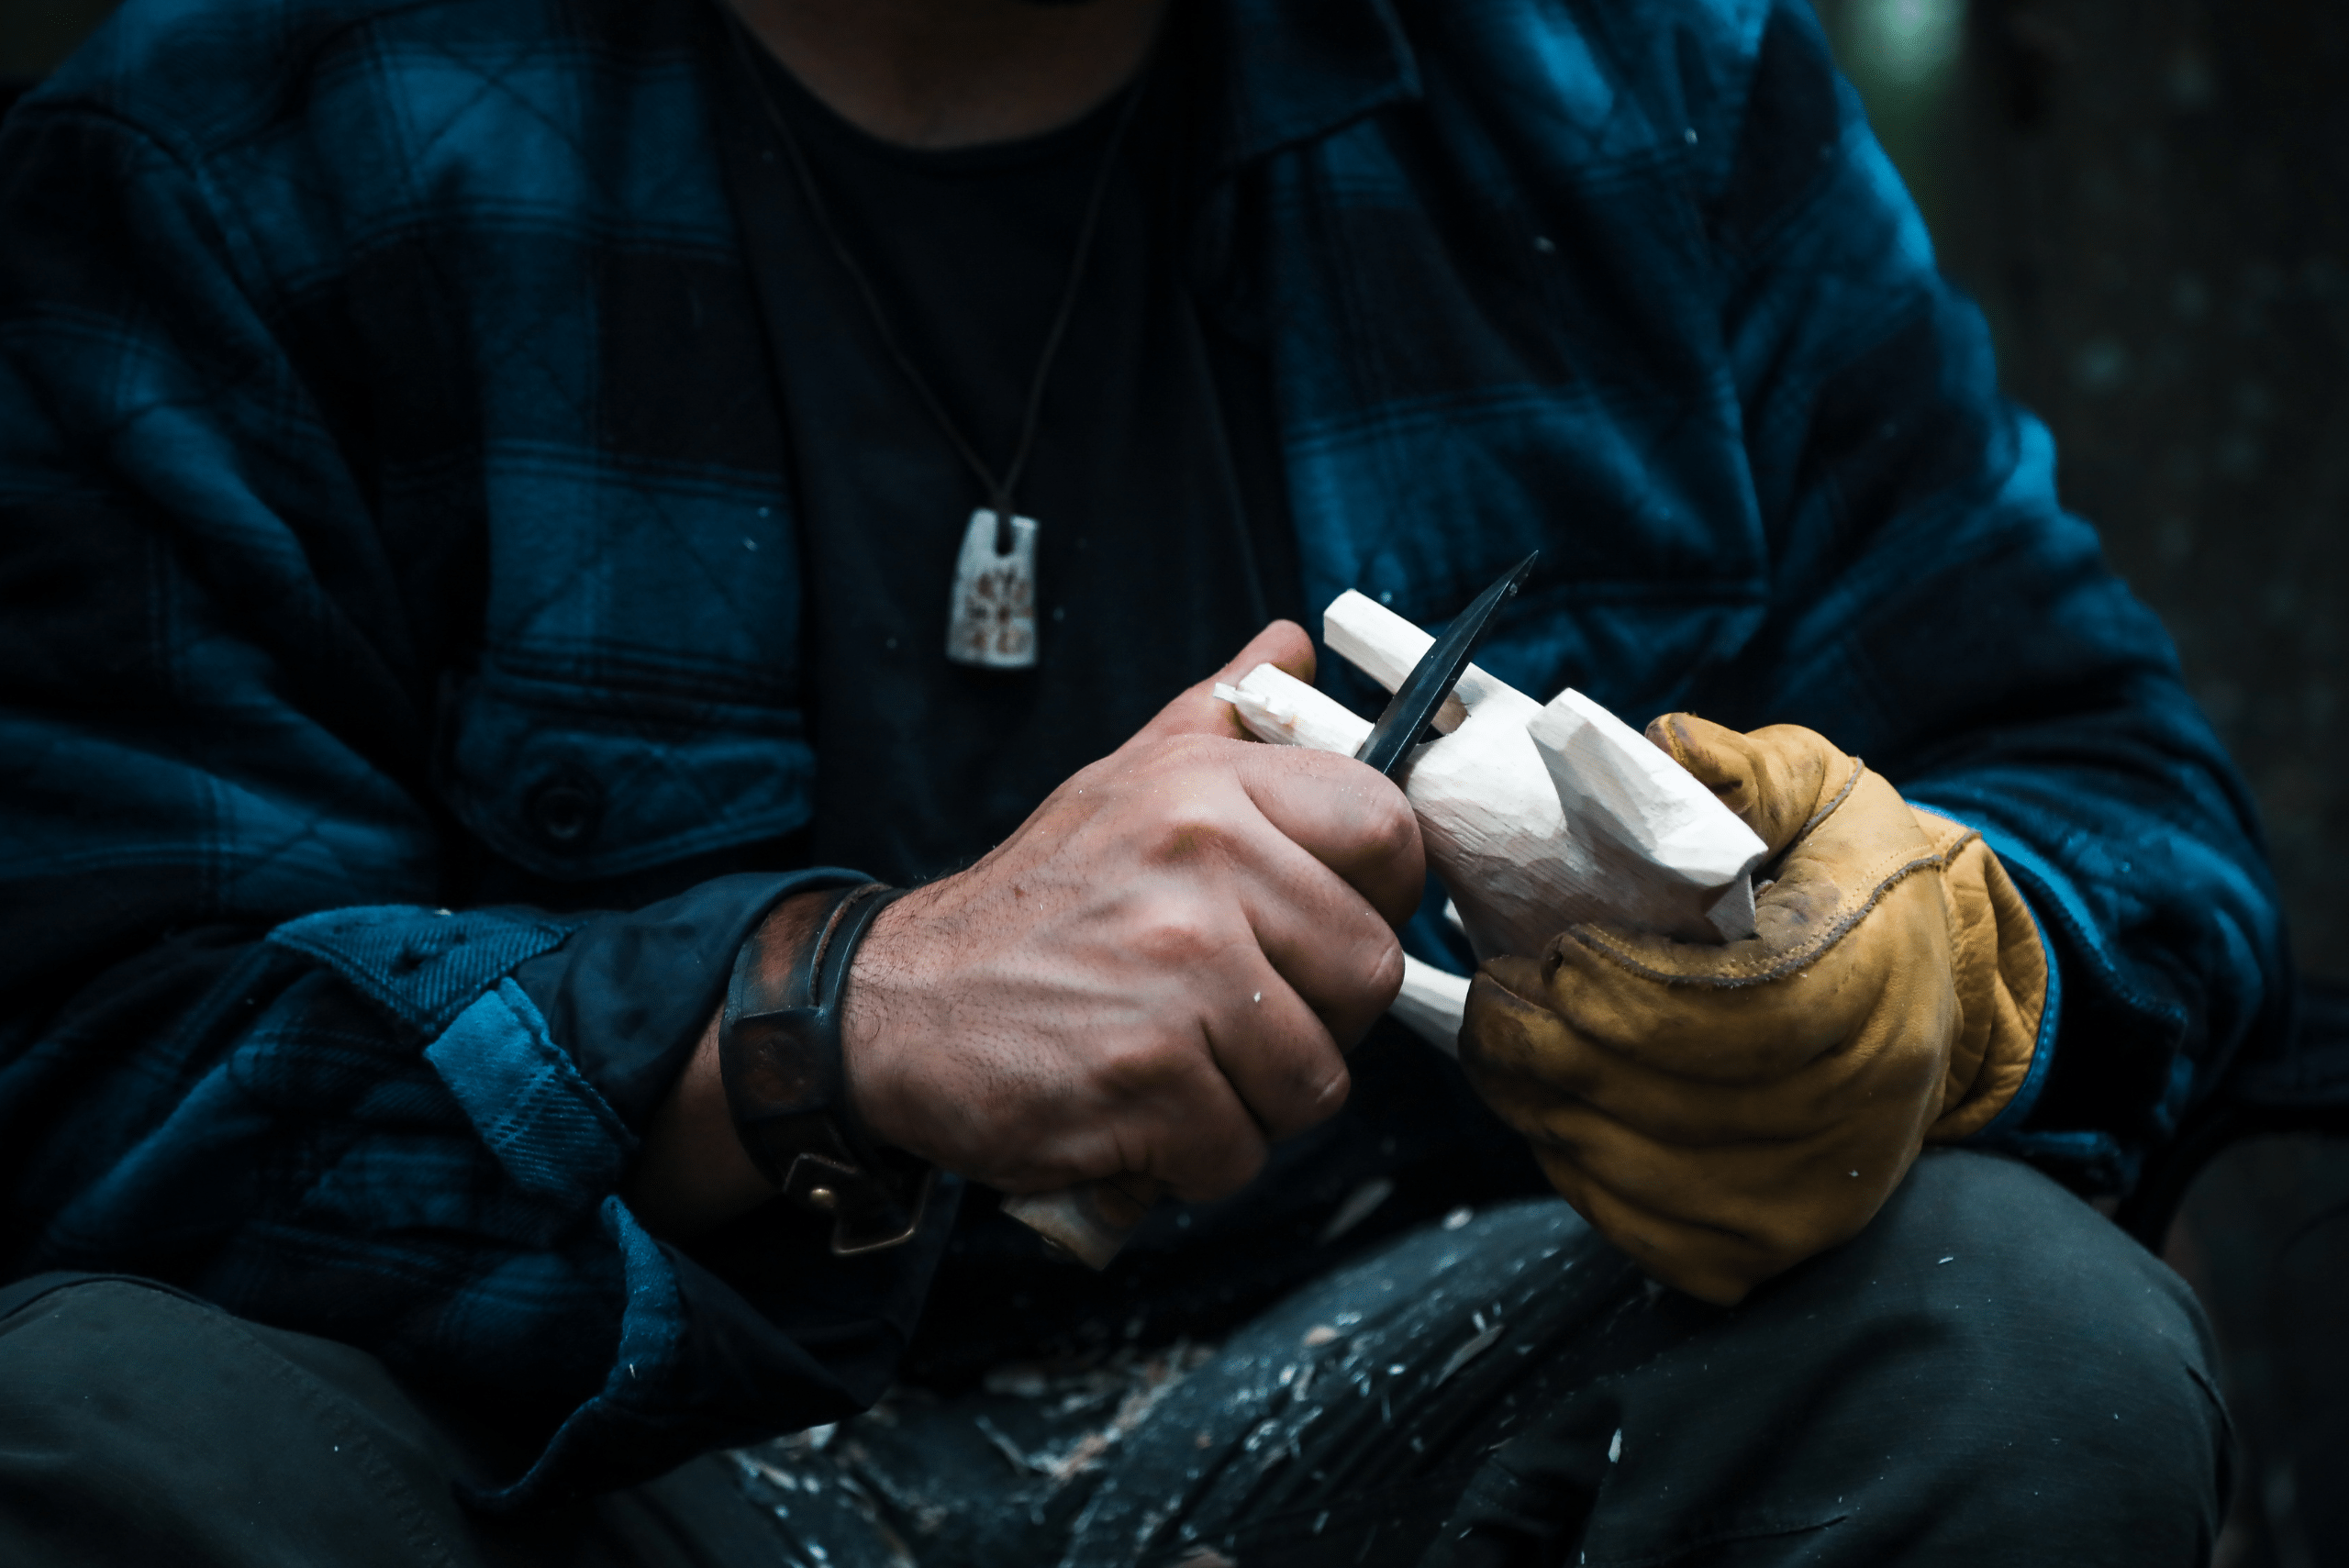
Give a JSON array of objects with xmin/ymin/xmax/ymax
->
[{"xmin": 1461, "ymin": 1152, "xmax": 2227, "ymax": 1563}]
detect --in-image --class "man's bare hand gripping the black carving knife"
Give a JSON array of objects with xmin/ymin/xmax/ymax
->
[{"xmin": 843, "ymin": 622, "xmax": 1423, "ymax": 1199}]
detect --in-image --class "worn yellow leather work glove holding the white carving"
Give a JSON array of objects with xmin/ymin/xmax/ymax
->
[{"xmin": 1461, "ymin": 714, "xmax": 2048, "ymax": 1305}]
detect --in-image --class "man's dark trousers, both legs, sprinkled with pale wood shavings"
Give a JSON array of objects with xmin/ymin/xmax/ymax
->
[{"xmin": 0, "ymin": 1152, "xmax": 2227, "ymax": 1568}]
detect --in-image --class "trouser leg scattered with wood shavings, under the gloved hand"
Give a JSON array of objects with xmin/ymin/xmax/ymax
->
[{"xmin": 785, "ymin": 1152, "xmax": 2227, "ymax": 1568}]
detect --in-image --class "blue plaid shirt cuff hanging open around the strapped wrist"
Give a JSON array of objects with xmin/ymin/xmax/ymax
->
[{"xmin": 443, "ymin": 869, "xmax": 961, "ymax": 1512}]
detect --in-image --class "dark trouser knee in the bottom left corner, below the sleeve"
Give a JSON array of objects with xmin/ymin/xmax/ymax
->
[{"xmin": 0, "ymin": 1274, "xmax": 782, "ymax": 1568}]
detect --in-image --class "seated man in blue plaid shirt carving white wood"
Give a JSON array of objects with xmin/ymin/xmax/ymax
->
[{"xmin": 0, "ymin": 0, "xmax": 2286, "ymax": 1568}]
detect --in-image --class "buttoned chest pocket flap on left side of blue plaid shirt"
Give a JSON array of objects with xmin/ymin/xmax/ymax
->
[{"xmin": 435, "ymin": 669, "xmax": 815, "ymax": 883}]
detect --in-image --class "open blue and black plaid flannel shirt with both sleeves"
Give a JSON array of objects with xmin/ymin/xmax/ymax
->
[{"xmin": 0, "ymin": 0, "xmax": 2283, "ymax": 1502}]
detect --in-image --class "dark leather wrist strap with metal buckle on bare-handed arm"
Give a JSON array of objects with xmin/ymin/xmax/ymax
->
[{"xmin": 718, "ymin": 883, "xmax": 937, "ymax": 1258}]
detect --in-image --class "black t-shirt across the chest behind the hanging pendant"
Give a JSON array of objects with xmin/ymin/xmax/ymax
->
[{"xmin": 751, "ymin": 42, "xmax": 1297, "ymax": 883}]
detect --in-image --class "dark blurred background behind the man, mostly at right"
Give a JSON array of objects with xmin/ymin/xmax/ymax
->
[{"xmin": 0, "ymin": 0, "xmax": 2349, "ymax": 1568}]
